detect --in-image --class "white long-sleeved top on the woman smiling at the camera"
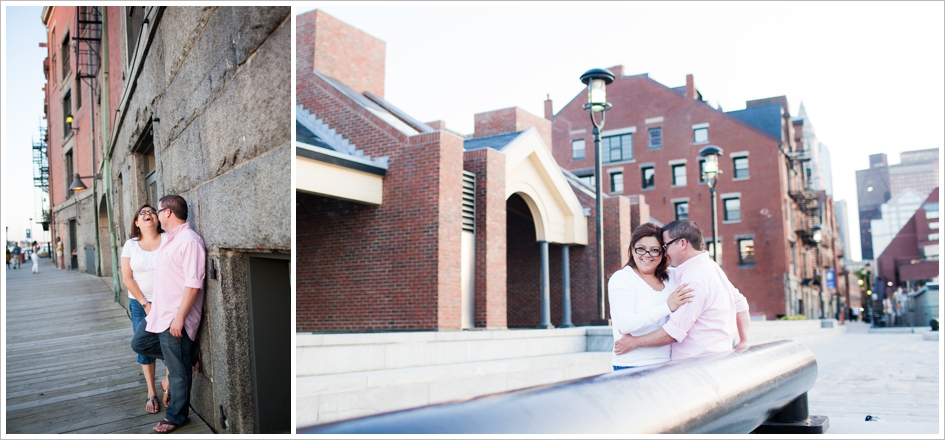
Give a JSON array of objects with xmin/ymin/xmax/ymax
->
[{"xmin": 607, "ymin": 266, "xmax": 676, "ymax": 367}]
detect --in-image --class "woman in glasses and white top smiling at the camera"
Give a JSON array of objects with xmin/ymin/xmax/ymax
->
[{"xmin": 607, "ymin": 223, "xmax": 692, "ymax": 371}]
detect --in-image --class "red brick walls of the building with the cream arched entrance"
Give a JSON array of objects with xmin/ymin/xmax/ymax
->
[{"xmin": 296, "ymin": 11, "xmax": 649, "ymax": 331}]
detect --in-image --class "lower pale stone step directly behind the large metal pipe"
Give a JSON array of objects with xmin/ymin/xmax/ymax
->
[{"xmin": 296, "ymin": 352, "xmax": 611, "ymax": 426}]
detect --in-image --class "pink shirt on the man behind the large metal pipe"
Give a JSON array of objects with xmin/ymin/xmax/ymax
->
[{"xmin": 663, "ymin": 251, "xmax": 748, "ymax": 360}]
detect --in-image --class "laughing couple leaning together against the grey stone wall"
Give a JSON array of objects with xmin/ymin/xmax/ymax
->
[{"xmin": 121, "ymin": 195, "xmax": 207, "ymax": 434}]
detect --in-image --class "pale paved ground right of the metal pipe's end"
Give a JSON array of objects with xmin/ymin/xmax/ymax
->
[{"xmin": 805, "ymin": 322, "xmax": 942, "ymax": 438}]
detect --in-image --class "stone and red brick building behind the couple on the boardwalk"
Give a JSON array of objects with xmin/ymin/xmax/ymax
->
[{"xmin": 42, "ymin": 6, "xmax": 292, "ymax": 433}]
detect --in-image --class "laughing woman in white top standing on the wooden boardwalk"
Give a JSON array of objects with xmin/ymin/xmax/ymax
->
[{"xmin": 121, "ymin": 204, "xmax": 170, "ymax": 414}]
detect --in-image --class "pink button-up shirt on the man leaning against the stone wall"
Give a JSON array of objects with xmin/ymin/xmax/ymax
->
[{"xmin": 145, "ymin": 223, "xmax": 207, "ymax": 340}]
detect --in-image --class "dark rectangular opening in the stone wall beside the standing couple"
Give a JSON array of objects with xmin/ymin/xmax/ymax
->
[{"xmin": 248, "ymin": 254, "xmax": 292, "ymax": 434}]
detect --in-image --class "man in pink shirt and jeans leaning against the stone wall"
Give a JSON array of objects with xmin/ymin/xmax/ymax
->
[{"xmin": 131, "ymin": 195, "xmax": 207, "ymax": 433}]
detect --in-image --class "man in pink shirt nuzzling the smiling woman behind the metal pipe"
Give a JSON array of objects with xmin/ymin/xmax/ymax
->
[{"xmin": 614, "ymin": 220, "xmax": 750, "ymax": 360}]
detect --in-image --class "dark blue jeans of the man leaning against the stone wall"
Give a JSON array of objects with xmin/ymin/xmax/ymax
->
[{"xmin": 131, "ymin": 321, "xmax": 196, "ymax": 425}]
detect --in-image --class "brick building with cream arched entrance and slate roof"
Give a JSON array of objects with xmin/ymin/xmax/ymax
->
[{"xmin": 296, "ymin": 10, "xmax": 648, "ymax": 332}]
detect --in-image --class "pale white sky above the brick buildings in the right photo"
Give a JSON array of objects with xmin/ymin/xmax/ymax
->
[{"xmin": 302, "ymin": 2, "xmax": 945, "ymax": 260}]
